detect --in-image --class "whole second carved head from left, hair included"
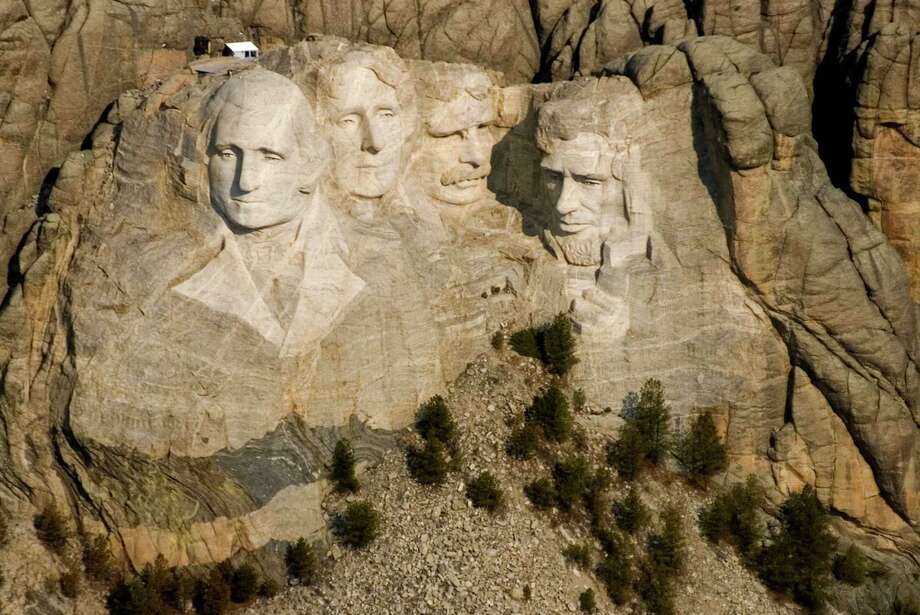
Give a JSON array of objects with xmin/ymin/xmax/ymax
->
[{"xmin": 317, "ymin": 47, "xmax": 417, "ymax": 200}]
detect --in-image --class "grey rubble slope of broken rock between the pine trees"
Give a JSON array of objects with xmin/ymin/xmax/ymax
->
[{"xmin": 246, "ymin": 351, "xmax": 800, "ymax": 615}]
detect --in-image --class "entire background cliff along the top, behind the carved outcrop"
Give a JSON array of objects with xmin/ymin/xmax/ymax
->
[{"xmin": 0, "ymin": 0, "xmax": 920, "ymax": 308}]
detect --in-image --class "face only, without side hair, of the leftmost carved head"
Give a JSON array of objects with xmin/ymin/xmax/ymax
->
[{"xmin": 208, "ymin": 82, "xmax": 307, "ymax": 231}]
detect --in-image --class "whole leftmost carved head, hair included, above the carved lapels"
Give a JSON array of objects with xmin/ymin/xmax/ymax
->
[{"xmin": 207, "ymin": 68, "xmax": 327, "ymax": 232}]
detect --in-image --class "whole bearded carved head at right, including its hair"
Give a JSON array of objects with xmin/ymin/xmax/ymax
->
[{"xmin": 537, "ymin": 80, "xmax": 629, "ymax": 266}]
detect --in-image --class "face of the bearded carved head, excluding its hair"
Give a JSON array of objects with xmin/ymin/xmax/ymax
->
[{"xmin": 541, "ymin": 132, "xmax": 626, "ymax": 266}]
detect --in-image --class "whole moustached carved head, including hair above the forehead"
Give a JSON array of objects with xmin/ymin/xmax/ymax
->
[{"xmin": 413, "ymin": 63, "xmax": 498, "ymax": 205}]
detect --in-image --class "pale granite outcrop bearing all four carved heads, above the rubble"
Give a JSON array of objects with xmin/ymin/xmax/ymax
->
[{"xmin": 0, "ymin": 32, "xmax": 920, "ymax": 612}]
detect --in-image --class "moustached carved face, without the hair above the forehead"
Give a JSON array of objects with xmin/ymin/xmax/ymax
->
[{"xmin": 416, "ymin": 94, "xmax": 495, "ymax": 205}]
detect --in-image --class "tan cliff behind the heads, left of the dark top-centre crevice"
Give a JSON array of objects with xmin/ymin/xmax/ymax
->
[{"xmin": 0, "ymin": 0, "xmax": 540, "ymax": 298}]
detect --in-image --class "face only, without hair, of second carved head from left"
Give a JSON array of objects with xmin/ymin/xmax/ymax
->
[{"xmin": 324, "ymin": 64, "xmax": 405, "ymax": 198}]
